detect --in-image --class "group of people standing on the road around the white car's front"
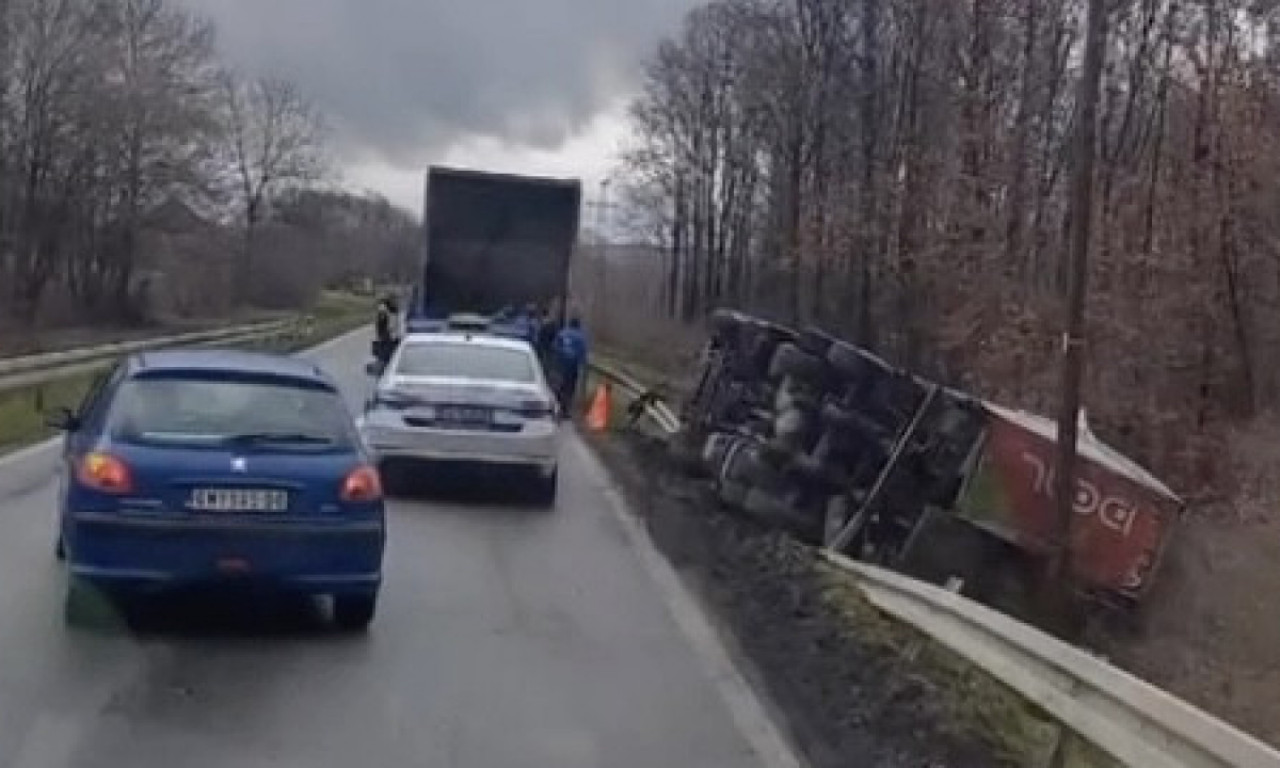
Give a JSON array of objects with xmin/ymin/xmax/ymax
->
[{"xmin": 374, "ymin": 296, "xmax": 588, "ymax": 413}]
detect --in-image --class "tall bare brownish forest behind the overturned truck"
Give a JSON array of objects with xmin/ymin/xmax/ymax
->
[{"xmin": 625, "ymin": 0, "xmax": 1280, "ymax": 485}]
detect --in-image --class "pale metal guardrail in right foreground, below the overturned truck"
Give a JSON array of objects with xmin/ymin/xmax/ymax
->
[{"xmin": 823, "ymin": 550, "xmax": 1280, "ymax": 768}]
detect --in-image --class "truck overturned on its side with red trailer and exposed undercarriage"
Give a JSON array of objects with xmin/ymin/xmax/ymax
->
[{"xmin": 682, "ymin": 311, "xmax": 1183, "ymax": 605}]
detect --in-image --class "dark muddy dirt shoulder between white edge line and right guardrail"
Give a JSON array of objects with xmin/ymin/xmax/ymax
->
[{"xmin": 594, "ymin": 433, "xmax": 1108, "ymax": 768}]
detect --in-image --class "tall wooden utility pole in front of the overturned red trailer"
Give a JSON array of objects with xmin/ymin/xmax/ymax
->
[{"xmin": 1050, "ymin": 0, "xmax": 1107, "ymax": 580}]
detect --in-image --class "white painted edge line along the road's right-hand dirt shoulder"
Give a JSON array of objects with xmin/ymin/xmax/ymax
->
[{"xmin": 571, "ymin": 431, "xmax": 808, "ymax": 768}]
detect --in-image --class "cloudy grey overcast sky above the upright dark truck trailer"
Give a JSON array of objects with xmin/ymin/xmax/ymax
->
[{"xmin": 184, "ymin": 0, "xmax": 696, "ymax": 210}]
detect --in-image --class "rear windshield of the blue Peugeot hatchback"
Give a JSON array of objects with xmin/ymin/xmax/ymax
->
[{"xmin": 108, "ymin": 376, "xmax": 353, "ymax": 449}]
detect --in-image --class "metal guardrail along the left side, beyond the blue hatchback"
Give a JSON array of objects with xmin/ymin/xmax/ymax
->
[{"xmin": 0, "ymin": 317, "xmax": 302, "ymax": 393}]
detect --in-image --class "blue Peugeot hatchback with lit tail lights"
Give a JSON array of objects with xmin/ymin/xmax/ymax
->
[{"xmin": 52, "ymin": 351, "xmax": 387, "ymax": 628}]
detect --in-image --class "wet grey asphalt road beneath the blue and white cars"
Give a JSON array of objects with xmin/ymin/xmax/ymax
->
[{"xmin": 0, "ymin": 337, "xmax": 787, "ymax": 768}]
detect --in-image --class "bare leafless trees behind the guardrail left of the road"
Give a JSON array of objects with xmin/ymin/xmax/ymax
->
[{"xmin": 0, "ymin": 0, "xmax": 413, "ymax": 324}]
